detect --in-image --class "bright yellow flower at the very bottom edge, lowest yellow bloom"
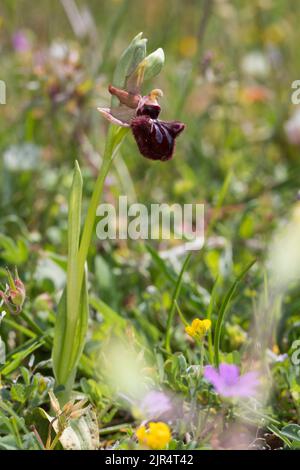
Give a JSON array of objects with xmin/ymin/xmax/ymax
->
[{"xmin": 136, "ymin": 422, "xmax": 172, "ymax": 450}]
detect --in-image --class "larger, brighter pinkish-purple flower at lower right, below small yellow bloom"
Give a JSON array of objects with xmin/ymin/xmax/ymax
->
[{"xmin": 204, "ymin": 364, "xmax": 259, "ymax": 397}]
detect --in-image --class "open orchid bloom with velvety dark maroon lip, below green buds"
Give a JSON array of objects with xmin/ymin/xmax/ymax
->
[{"xmin": 98, "ymin": 85, "xmax": 185, "ymax": 161}]
